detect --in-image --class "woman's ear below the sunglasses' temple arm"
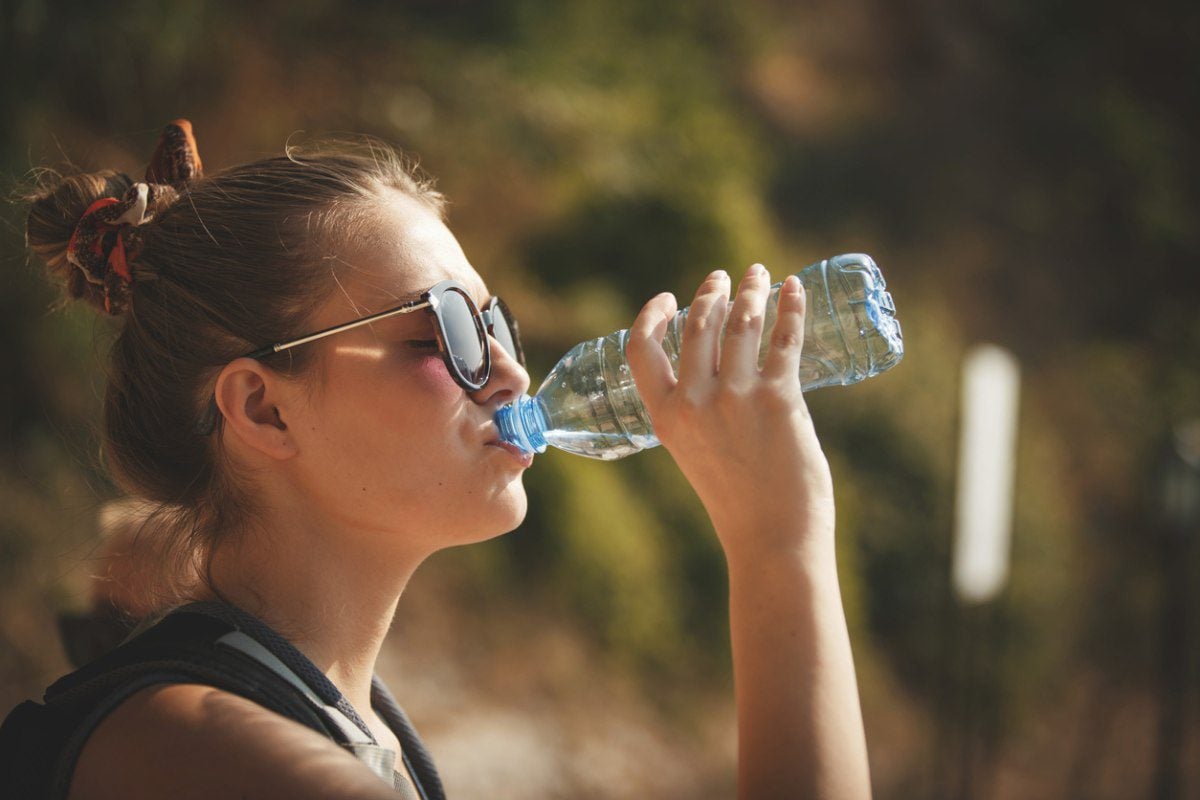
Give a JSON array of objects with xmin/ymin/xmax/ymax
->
[{"xmin": 215, "ymin": 359, "xmax": 296, "ymax": 461}]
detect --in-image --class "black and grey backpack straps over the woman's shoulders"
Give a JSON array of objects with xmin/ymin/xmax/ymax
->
[{"xmin": 0, "ymin": 602, "xmax": 444, "ymax": 800}]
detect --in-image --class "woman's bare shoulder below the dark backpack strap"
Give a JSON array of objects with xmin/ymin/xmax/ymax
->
[{"xmin": 70, "ymin": 684, "xmax": 395, "ymax": 800}]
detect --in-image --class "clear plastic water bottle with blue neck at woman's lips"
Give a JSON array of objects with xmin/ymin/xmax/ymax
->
[{"xmin": 496, "ymin": 253, "xmax": 904, "ymax": 459}]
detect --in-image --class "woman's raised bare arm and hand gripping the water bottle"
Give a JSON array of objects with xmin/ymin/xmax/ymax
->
[{"xmin": 628, "ymin": 265, "xmax": 870, "ymax": 800}]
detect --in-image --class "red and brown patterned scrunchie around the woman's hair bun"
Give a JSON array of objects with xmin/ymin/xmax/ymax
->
[{"xmin": 67, "ymin": 120, "xmax": 203, "ymax": 315}]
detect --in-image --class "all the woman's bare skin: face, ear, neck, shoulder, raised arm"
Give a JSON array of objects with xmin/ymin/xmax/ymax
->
[{"xmin": 71, "ymin": 193, "xmax": 870, "ymax": 800}]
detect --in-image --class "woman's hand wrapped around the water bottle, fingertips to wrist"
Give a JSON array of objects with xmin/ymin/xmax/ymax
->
[{"xmin": 626, "ymin": 264, "xmax": 834, "ymax": 560}]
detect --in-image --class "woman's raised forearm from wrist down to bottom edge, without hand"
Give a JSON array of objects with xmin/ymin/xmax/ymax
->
[{"xmin": 728, "ymin": 536, "xmax": 871, "ymax": 800}]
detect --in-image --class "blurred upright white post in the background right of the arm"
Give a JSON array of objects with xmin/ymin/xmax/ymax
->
[{"xmin": 952, "ymin": 344, "xmax": 1020, "ymax": 603}]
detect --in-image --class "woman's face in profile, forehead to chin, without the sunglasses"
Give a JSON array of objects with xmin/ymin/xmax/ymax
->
[{"xmin": 279, "ymin": 191, "xmax": 529, "ymax": 552}]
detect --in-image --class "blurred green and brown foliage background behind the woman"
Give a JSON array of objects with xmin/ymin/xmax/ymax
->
[{"xmin": 0, "ymin": 0, "xmax": 1200, "ymax": 800}]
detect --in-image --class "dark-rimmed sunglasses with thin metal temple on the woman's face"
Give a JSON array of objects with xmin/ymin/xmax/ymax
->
[{"xmin": 196, "ymin": 281, "xmax": 524, "ymax": 435}]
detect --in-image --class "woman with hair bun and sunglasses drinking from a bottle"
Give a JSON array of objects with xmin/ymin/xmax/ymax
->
[{"xmin": 9, "ymin": 120, "xmax": 870, "ymax": 800}]
